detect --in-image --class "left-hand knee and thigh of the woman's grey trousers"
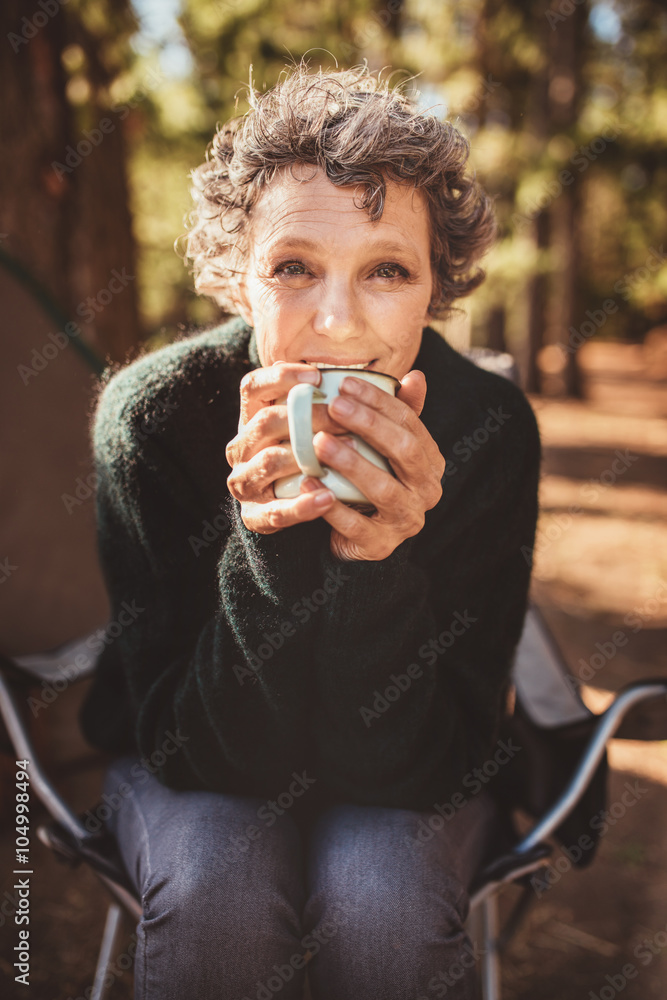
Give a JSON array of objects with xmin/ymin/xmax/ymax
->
[{"xmin": 125, "ymin": 793, "xmax": 304, "ymax": 1000}]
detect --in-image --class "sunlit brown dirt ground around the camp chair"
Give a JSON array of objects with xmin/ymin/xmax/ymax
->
[{"xmin": 0, "ymin": 344, "xmax": 667, "ymax": 1000}]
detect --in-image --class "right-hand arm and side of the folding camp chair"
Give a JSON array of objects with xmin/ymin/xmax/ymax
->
[{"xmin": 469, "ymin": 606, "xmax": 667, "ymax": 1000}]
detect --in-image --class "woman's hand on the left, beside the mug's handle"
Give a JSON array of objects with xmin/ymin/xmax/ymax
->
[{"xmin": 225, "ymin": 361, "xmax": 345, "ymax": 534}]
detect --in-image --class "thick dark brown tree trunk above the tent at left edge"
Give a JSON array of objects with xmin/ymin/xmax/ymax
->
[{"xmin": 0, "ymin": 0, "xmax": 141, "ymax": 360}]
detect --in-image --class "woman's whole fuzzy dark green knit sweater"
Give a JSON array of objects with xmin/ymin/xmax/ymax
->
[{"xmin": 81, "ymin": 318, "xmax": 540, "ymax": 809}]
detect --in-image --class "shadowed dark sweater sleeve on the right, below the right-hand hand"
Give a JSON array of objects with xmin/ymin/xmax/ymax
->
[{"xmin": 314, "ymin": 383, "xmax": 540, "ymax": 808}]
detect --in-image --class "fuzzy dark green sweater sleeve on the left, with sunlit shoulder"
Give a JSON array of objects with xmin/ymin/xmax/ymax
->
[{"xmin": 82, "ymin": 362, "xmax": 334, "ymax": 795}]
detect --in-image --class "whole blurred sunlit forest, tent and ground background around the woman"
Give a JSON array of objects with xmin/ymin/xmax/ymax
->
[{"xmin": 0, "ymin": 0, "xmax": 667, "ymax": 1000}]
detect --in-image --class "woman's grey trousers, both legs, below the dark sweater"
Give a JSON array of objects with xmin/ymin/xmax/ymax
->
[{"xmin": 104, "ymin": 757, "xmax": 497, "ymax": 1000}]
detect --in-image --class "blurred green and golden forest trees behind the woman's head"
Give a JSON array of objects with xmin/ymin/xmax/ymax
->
[{"xmin": 0, "ymin": 0, "xmax": 667, "ymax": 396}]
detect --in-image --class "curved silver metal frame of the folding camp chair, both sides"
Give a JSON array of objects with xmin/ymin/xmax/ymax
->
[{"xmin": 0, "ymin": 606, "xmax": 667, "ymax": 1000}]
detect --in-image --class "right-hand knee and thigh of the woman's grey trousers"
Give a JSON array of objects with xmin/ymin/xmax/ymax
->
[{"xmin": 305, "ymin": 807, "xmax": 474, "ymax": 1000}]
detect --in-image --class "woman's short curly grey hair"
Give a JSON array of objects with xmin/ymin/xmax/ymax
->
[{"xmin": 186, "ymin": 61, "xmax": 496, "ymax": 318}]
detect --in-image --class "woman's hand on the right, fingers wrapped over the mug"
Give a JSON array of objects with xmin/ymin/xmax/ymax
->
[{"xmin": 302, "ymin": 369, "xmax": 445, "ymax": 560}]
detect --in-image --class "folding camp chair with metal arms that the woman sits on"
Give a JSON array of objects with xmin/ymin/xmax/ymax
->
[{"xmin": 0, "ymin": 340, "xmax": 667, "ymax": 1000}]
